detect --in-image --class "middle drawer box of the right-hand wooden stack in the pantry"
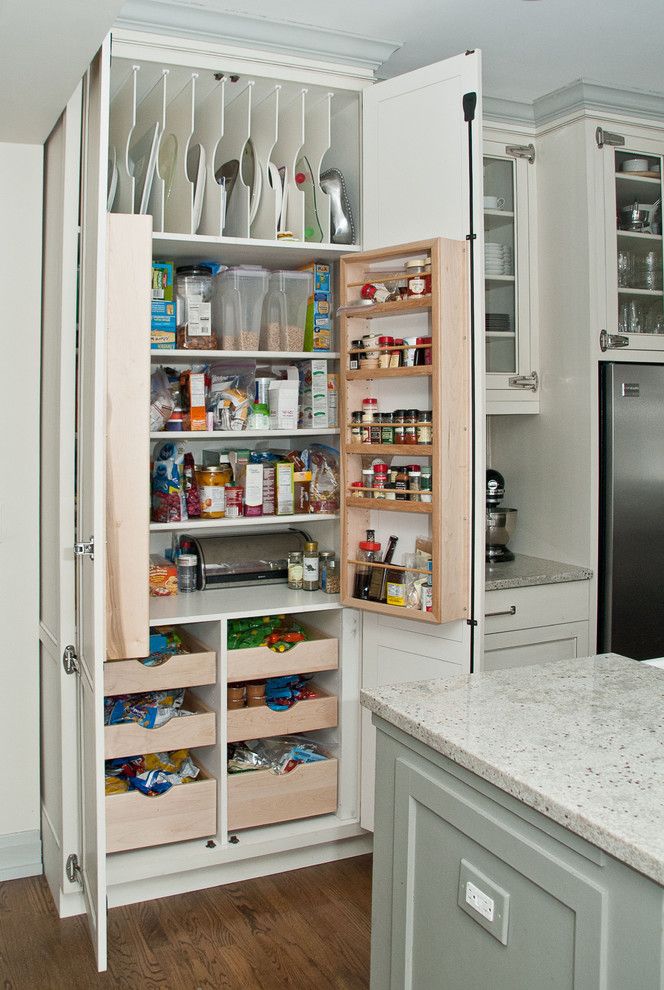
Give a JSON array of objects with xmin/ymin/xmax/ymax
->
[{"xmin": 226, "ymin": 692, "xmax": 337, "ymax": 742}]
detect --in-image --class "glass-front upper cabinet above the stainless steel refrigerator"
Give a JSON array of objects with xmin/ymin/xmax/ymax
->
[{"xmin": 597, "ymin": 129, "xmax": 664, "ymax": 360}]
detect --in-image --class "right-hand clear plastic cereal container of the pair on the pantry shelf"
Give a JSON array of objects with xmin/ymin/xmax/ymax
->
[{"xmin": 261, "ymin": 272, "xmax": 314, "ymax": 351}]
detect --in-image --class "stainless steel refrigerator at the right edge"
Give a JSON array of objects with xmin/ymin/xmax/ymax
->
[{"xmin": 597, "ymin": 363, "xmax": 664, "ymax": 660}]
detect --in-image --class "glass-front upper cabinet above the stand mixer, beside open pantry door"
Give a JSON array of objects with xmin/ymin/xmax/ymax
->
[{"xmin": 483, "ymin": 135, "xmax": 539, "ymax": 413}]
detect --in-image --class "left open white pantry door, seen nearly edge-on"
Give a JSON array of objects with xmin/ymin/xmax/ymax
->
[{"xmin": 76, "ymin": 38, "xmax": 110, "ymax": 970}]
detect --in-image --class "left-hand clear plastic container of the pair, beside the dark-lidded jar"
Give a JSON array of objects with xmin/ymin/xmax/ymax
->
[{"xmin": 212, "ymin": 268, "xmax": 269, "ymax": 351}]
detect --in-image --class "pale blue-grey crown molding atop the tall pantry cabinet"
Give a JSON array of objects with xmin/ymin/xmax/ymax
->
[{"xmin": 116, "ymin": 0, "xmax": 401, "ymax": 72}]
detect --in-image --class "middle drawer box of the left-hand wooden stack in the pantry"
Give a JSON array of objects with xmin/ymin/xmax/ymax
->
[{"xmin": 104, "ymin": 692, "xmax": 217, "ymax": 760}]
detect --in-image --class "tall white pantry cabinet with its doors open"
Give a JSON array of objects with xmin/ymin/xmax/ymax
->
[{"xmin": 42, "ymin": 32, "xmax": 484, "ymax": 968}]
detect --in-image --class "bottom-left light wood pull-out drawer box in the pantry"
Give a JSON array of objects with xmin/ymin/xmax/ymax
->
[{"xmin": 105, "ymin": 770, "xmax": 217, "ymax": 852}]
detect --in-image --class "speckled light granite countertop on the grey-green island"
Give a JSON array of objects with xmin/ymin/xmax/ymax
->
[{"xmin": 361, "ymin": 654, "xmax": 664, "ymax": 885}]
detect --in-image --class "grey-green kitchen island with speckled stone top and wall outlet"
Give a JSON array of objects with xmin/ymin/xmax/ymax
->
[{"xmin": 362, "ymin": 654, "xmax": 664, "ymax": 990}]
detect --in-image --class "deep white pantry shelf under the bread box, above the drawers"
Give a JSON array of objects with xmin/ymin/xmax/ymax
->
[{"xmin": 150, "ymin": 583, "xmax": 341, "ymax": 626}]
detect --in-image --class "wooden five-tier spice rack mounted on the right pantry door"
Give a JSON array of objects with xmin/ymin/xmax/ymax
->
[{"xmin": 339, "ymin": 238, "xmax": 471, "ymax": 623}]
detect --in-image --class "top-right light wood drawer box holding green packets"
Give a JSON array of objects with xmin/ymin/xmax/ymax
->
[{"xmin": 228, "ymin": 627, "xmax": 339, "ymax": 684}]
